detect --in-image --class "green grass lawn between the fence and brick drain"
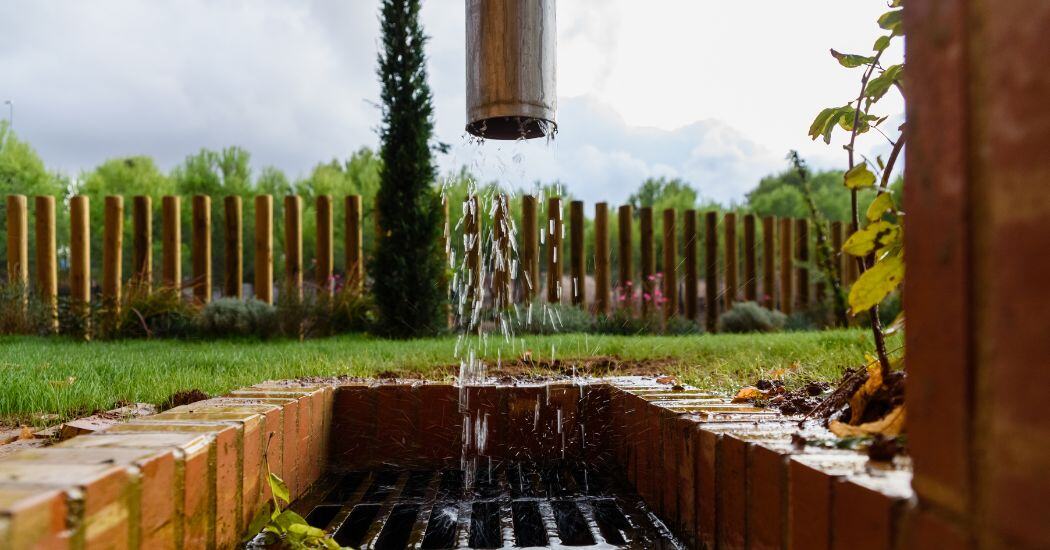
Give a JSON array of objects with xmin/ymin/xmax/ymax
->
[{"xmin": 0, "ymin": 330, "xmax": 896, "ymax": 424}]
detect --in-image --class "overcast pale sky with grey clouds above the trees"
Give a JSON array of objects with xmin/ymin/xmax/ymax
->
[{"xmin": 0, "ymin": 0, "xmax": 902, "ymax": 203}]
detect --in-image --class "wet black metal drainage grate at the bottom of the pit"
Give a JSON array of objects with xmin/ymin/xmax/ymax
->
[{"xmin": 298, "ymin": 463, "xmax": 684, "ymax": 550}]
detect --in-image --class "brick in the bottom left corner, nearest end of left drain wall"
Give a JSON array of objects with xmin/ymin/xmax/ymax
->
[{"xmin": 0, "ymin": 485, "xmax": 69, "ymax": 550}]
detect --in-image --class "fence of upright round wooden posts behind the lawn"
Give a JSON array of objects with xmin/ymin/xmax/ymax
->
[{"xmin": 6, "ymin": 191, "xmax": 857, "ymax": 331}]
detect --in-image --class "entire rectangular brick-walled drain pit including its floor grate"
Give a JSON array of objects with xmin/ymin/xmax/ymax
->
[{"xmin": 0, "ymin": 378, "xmax": 916, "ymax": 550}]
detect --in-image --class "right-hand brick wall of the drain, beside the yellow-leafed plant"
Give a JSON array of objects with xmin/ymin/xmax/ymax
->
[{"xmin": 609, "ymin": 379, "xmax": 915, "ymax": 550}]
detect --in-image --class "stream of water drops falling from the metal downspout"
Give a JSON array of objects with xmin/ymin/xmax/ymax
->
[{"xmin": 442, "ymin": 128, "xmax": 584, "ymax": 488}]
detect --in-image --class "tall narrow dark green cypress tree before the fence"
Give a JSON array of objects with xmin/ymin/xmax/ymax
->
[{"xmin": 371, "ymin": 0, "xmax": 445, "ymax": 338}]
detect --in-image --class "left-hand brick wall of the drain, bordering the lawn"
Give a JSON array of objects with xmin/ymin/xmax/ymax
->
[{"xmin": 0, "ymin": 382, "xmax": 334, "ymax": 550}]
